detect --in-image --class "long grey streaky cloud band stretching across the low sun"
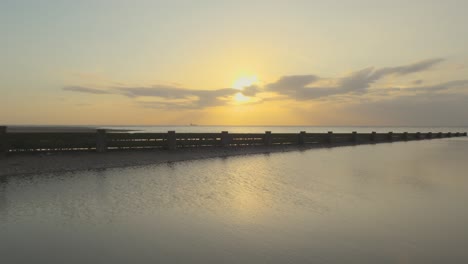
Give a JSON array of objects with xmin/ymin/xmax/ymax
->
[{"xmin": 63, "ymin": 58, "xmax": 468, "ymax": 112}]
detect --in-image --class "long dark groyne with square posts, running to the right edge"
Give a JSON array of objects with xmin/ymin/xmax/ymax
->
[{"xmin": 0, "ymin": 126, "xmax": 467, "ymax": 154}]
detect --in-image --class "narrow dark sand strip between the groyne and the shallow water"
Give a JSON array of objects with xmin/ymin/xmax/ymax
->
[{"xmin": 0, "ymin": 146, "xmax": 336, "ymax": 177}]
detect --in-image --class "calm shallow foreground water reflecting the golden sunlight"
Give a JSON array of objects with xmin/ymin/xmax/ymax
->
[{"xmin": 0, "ymin": 137, "xmax": 468, "ymax": 263}]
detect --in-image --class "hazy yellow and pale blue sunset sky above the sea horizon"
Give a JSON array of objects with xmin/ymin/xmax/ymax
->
[{"xmin": 0, "ymin": 0, "xmax": 468, "ymax": 126}]
